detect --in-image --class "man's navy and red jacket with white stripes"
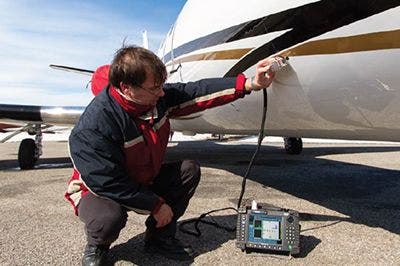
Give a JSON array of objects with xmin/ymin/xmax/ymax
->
[{"xmin": 65, "ymin": 75, "xmax": 245, "ymax": 213}]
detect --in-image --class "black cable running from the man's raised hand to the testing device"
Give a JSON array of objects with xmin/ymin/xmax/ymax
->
[{"xmin": 179, "ymin": 89, "xmax": 268, "ymax": 237}]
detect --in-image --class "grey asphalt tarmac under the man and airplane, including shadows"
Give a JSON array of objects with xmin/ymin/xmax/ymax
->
[{"xmin": 0, "ymin": 141, "xmax": 400, "ymax": 265}]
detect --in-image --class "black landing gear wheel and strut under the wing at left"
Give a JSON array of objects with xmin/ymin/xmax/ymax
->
[{"xmin": 18, "ymin": 124, "xmax": 42, "ymax": 170}]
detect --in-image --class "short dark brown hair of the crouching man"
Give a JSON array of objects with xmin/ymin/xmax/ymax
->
[{"xmin": 108, "ymin": 45, "xmax": 167, "ymax": 88}]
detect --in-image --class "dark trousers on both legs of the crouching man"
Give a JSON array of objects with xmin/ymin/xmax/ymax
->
[{"xmin": 78, "ymin": 160, "xmax": 200, "ymax": 246}]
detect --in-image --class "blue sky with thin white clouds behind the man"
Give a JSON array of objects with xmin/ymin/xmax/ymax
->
[{"xmin": 0, "ymin": 0, "xmax": 186, "ymax": 105}]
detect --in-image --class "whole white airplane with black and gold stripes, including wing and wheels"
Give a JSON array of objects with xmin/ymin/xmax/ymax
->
[{"xmin": 0, "ymin": 0, "xmax": 400, "ymax": 169}]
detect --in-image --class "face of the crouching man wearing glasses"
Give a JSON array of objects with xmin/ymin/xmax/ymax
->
[{"xmin": 121, "ymin": 68, "xmax": 165, "ymax": 106}]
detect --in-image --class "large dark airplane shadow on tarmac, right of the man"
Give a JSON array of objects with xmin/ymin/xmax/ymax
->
[{"xmin": 163, "ymin": 139, "xmax": 400, "ymax": 234}]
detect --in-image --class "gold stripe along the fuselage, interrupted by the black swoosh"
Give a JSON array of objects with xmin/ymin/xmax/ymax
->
[{"xmin": 166, "ymin": 30, "xmax": 400, "ymax": 66}]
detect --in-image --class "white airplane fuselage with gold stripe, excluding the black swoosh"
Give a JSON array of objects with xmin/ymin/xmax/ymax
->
[{"xmin": 159, "ymin": 0, "xmax": 400, "ymax": 141}]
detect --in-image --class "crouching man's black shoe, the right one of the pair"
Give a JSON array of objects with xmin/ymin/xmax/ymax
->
[{"xmin": 144, "ymin": 237, "xmax": 197, "ymax": 261}]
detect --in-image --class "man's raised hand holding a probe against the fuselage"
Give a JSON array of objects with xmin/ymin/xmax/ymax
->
[{"xmin": 245, "ymin": 57, "xmax": 283, "ymax": 91}]
